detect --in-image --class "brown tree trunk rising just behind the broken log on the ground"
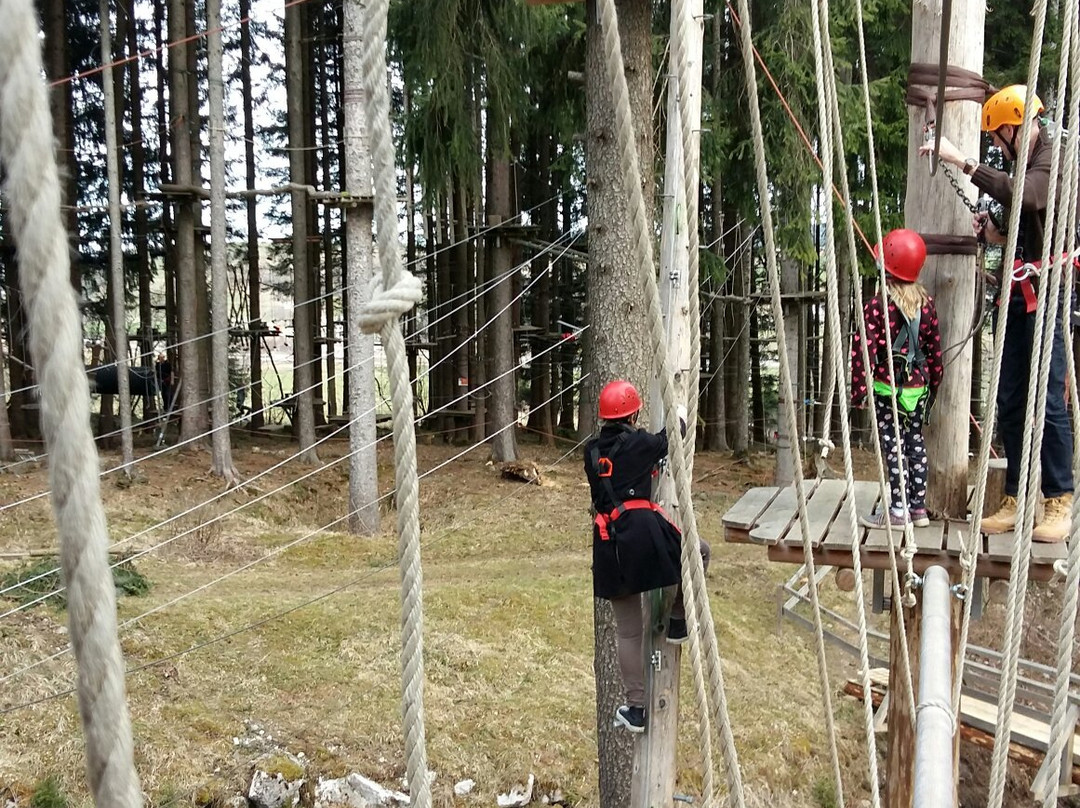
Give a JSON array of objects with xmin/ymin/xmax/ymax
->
[{"xmin": 487, "ymin": 154, "xmax": 520, "ymax": 462}]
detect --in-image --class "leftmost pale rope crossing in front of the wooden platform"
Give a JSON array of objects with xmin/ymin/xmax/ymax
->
[{"xmin": 725, "ymin": 0, "xmax": 843, "ymax": 808}]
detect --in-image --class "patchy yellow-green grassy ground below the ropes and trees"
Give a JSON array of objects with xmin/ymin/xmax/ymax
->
[{"xmin": 0, "ymin": 436, "xmax": 1045, "ymax": 808}]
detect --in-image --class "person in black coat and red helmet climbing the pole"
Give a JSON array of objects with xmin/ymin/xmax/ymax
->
[{"xmin": 585, "ymin": 381, "xmax": 708, "ymax": 732}]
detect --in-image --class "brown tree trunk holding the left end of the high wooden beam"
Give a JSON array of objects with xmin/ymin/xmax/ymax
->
[{"xmin": 168, "ymin": 0, "xmax": 206, "ymax": 442}]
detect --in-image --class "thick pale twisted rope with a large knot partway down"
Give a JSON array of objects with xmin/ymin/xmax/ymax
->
[{"xmin": 359, "ymin": 0, "xmax": 431, "ymax": 808}]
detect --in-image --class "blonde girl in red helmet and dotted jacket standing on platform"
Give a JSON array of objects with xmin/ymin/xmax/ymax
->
[{"xmin": 851, "ymin": 229, "xmax": 943, "ymax": 527}]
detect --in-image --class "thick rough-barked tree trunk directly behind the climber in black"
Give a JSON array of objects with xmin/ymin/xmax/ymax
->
[{"xmin": 580, "ymin": 0, "xmax": 654, "ymax": 808}]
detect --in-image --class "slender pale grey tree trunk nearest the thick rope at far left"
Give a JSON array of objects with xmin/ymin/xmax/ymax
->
[{"xmin": 98, "ymin": 0, "xmax": 135, "ymax": 466}]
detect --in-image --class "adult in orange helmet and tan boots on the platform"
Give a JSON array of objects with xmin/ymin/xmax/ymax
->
[{"xmin": 920, "ymin": 84, "xmax": 1074, "ymax": 541}]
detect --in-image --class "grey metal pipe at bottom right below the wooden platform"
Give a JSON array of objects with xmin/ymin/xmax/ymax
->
[{"xmin": 913, "ymin": 566, "xmax": 956, "ymax": 808}]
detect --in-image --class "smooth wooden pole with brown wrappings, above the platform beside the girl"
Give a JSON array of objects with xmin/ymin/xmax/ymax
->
[{"xmin": 905, "ymin": 0, "xmax": 986, "ymax": 519}]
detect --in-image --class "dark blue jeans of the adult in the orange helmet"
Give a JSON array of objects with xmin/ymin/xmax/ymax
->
[{"xmin": 998, "ymin": 297, "xmax": 1072, "ymax": 497}]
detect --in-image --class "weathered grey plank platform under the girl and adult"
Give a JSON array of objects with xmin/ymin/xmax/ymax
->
[{"xmin": 724, "ymin": 480, "xmax": 1068, "ymax": 581}]
